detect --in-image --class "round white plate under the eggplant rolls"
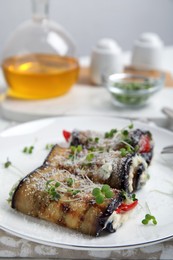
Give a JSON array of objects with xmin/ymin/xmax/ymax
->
[{"xmin": 0, "ymin": 117, "xmax": 173, "ymax": 250}]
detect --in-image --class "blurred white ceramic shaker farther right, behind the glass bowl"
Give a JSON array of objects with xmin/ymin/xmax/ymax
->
[{"xmin": 131, "ymin": 33, "xmax": 164, "ymax": 70}]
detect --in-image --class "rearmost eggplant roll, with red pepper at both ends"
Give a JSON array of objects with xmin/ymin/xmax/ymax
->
[{"xmin": 63, "ymin": 127, "xmax": 154, "ymax": 165}]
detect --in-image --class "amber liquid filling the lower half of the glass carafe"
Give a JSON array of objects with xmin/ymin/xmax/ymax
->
[{"xmin": 2, "ymin": 54, "xmax": 79, "ymax": 99}]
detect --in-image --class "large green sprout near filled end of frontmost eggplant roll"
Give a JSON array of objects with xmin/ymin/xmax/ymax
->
[{"xmin": 92, "ymin": 184, "xmax": 113, "ymax": 204}]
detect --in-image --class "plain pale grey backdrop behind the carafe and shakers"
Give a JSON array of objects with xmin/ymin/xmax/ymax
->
[{"xmin": 0, "ymin": 0, "xmax": 173, "ymax": 58}]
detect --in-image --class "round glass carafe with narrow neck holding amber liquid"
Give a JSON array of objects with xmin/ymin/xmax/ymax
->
[{"xmin": 2, "ymin": 0, "xmax": 79, "ymax": 99}]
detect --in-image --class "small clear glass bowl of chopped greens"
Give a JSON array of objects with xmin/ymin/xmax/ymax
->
[{"xmin": 104, "ymin": 72, "xmax": 165, "ymax": 107}]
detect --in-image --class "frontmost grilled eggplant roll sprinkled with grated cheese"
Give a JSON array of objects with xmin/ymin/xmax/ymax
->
[{"xmin": 11, "ymin": 165, "xmax": 132, "ymax": 236}]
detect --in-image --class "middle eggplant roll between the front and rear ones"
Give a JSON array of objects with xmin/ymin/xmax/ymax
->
[{"xmin": 44, "ymin": 145, "xmax": 148, "ymax": 193}]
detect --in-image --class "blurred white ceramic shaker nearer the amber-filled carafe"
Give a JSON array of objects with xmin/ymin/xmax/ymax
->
[{"xmin": 90, "ymin": 38, "xmax": 123, "ymax": 85}]
